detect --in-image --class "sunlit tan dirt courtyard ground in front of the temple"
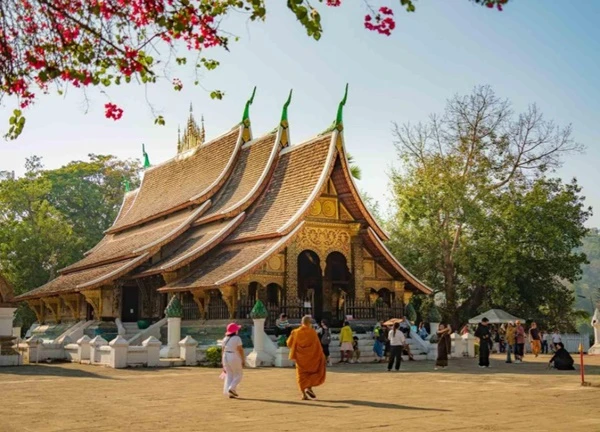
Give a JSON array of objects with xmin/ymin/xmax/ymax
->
[{"xmin": 0, "ymin": 356, "xmax": 600, "ymax": 432}]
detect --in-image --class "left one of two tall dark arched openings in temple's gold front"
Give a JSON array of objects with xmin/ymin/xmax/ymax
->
[{"xmin": 298, "ymin": 250, "xmax": 328, "ymax": 320}]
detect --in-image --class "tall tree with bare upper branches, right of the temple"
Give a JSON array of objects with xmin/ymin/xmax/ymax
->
[{"xmin": 390, "ymin": 86, "xmax": 591, "ymax": 326}]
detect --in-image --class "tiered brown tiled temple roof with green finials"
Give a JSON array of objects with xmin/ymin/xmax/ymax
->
[{"xmin": 16, "ymin": 89, "xmax": 431, "ymax": 300}]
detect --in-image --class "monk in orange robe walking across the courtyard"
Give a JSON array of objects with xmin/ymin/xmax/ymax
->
[{"xmin": 287, "ymin": 316, "xmax": 327, "ymax": 400}]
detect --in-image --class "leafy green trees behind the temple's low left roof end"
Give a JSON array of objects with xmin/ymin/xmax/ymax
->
[{"xmin": 0, "ymin": 155, "xmax": 139, "ymax": 325}]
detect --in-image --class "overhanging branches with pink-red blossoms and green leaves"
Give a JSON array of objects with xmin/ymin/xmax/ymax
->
[{"xmin": 0, "ymin": 0, "xmax": 508, "ymax": 139}]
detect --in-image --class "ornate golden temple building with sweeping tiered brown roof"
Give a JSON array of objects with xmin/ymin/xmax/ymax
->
[{"xmin": 16, "ymin": 88, "xmax": 431, "ymax": 330}]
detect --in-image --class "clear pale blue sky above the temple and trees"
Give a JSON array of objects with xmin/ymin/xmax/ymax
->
[{"xmin": 0, "ymin": 0, "xmax": 600, "ymax": 226}]
